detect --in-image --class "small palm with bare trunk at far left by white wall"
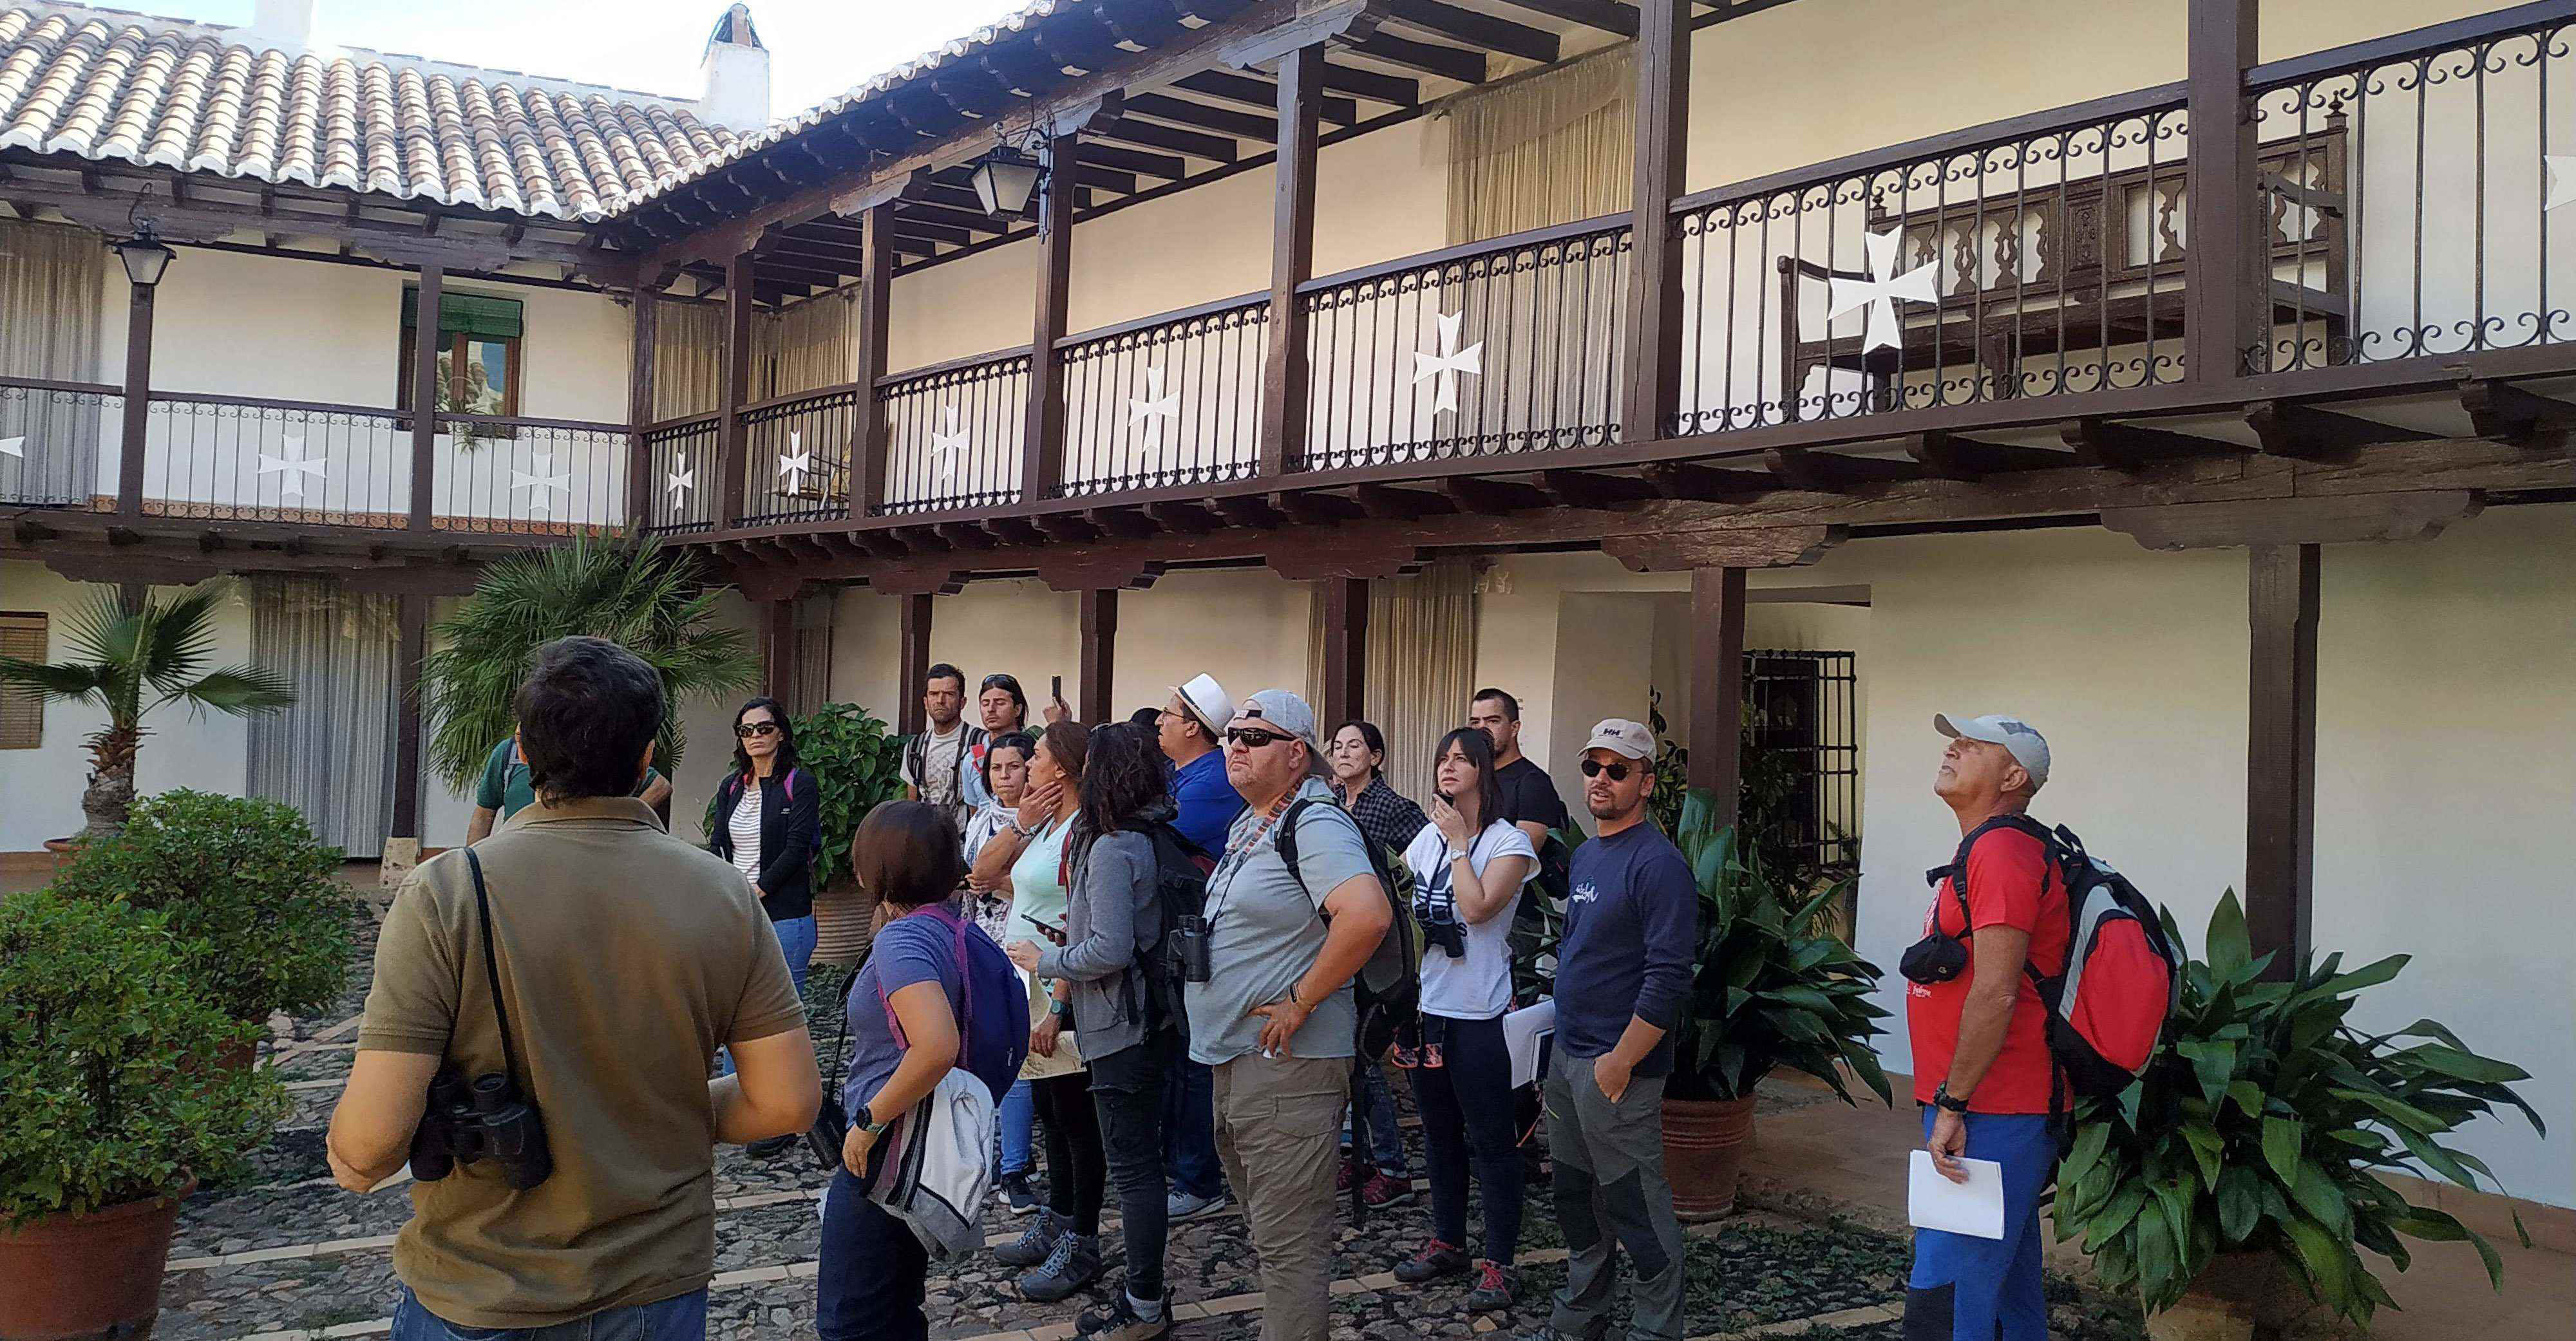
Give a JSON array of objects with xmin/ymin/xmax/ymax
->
[{"xmin": 0, "ymin": 585, "xmax": 296, "ymax": 841}]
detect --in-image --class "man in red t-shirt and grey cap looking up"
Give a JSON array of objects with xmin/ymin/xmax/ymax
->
[{"xmin": 1906, "ymin": 713, "xmax": 2074, "ymax": 1341}]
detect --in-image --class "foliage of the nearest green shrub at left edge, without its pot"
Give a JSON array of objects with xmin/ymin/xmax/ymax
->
[{"xmin": 0, "ymin": 890, "xmax": 286, "ymax": 1225}]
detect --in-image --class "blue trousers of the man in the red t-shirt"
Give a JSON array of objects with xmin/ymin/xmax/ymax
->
[{"xmin": 1906, "ymin": 1107, "xmax": 2058, "ymax": 1341}]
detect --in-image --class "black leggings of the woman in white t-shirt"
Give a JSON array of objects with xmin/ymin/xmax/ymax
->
[{"xmin": 1412, "ymin": 1014, "xmax": 1522, "ymax": 1266}]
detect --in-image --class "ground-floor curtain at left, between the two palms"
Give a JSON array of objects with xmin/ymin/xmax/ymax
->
[{"xmin": 247, "ymin": 577, "xmax": 399, "ymax": 859}]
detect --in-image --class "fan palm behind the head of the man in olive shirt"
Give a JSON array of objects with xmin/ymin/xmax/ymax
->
[{"xmin": 420, "ymin": 536, "xmax": 760, "ymax": 790}]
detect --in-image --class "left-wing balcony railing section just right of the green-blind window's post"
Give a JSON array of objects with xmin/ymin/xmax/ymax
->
[{"xmin": 430, "ymin": 415, "xmax": 634, "ymax": 536}]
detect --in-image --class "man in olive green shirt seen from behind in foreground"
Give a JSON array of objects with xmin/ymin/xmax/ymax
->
[{"xmin": 327, "ymin": 639, "xmax": 822, "ymax": 1341}]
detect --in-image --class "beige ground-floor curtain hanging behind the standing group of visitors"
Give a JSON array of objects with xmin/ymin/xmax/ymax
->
[{"xmin": 1306, "ymin": 559, "xmax": 1476, "ymax": 800}]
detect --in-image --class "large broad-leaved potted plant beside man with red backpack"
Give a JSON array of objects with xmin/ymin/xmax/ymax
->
[{"xmin": 2056, "ymin": 890, "xmax": 2543, "ymax": 1341}]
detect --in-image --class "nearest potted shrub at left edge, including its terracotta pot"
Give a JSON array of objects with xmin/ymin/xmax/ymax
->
[{"xmin": 0, "ymin": 890, "xmax": 286, "ymax": 1336}]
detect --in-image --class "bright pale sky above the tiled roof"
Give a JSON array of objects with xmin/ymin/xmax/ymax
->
[{"xmin": 148, "ymin": 0, "xmax": 1028, "ymax": 116}]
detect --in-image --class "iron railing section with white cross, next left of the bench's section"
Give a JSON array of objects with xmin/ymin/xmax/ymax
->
[{"xmin": 1288, "ymin": 219, "xmax": 1628, "ymax": 471}]
